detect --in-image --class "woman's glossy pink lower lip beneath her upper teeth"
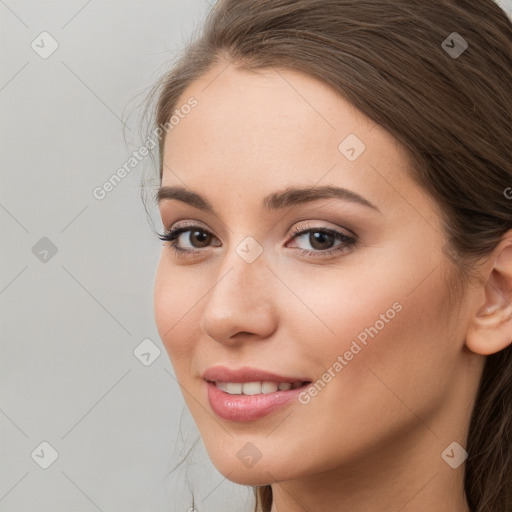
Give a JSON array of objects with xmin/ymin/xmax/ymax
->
[{"xmin": 206, "ymin": 382, "xmax": 308, "ymax": 421}]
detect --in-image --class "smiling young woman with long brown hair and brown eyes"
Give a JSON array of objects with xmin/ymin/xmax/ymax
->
[{"xmin": 143, "ymin": 0, "xmax": 512, "ymax": 512}]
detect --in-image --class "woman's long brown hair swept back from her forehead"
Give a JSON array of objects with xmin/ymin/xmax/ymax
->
[{"xmin": 141, "ymin": 0, "xmax": 512, "ymax": 512}]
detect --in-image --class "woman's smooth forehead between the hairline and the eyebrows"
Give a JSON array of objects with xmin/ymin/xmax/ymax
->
[{"xmin": 162, "ymin": 64, "xmax": 436, "ymax": 224}]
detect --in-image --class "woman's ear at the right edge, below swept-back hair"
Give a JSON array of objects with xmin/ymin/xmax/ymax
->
[{"xmin": 466, "ymin": 230, "xmax": 512, "ymax": 355}]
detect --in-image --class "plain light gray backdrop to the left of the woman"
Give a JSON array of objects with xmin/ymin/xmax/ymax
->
[{"xmin": 0, "ymin": 0, "xmax": 512, "ymax": 512}]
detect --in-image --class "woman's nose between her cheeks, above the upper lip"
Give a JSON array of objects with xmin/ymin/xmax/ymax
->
[{"xmin": 200, "ymin": 247, "xmax": 277, "ymax": 345}]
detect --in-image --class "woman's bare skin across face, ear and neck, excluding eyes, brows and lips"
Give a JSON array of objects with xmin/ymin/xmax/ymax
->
[{"xmin": 154, "ymin": 63, "xmax": 512, "ymax": 512}]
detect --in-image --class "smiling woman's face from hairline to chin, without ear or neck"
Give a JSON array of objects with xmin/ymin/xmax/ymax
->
[{"xmin": 154, "ymin": 64, "xmax": 478, "ymax": 485}]
